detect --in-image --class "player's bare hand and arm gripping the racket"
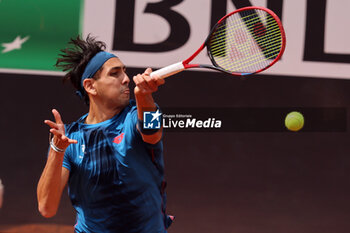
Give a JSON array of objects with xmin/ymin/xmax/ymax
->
[{"xmin": 133, "ymin": 68, "xmax": 165, "ymax": 144}]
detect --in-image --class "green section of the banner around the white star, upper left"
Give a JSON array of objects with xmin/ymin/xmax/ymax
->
[{"xmin": 0, "ymin": 0, "xmax": 83, "ymax": 71}]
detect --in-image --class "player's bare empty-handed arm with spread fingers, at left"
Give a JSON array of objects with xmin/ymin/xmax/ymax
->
[{"xmin": 37, "ymin": 109, "xmax": 77, "ymax": 218}]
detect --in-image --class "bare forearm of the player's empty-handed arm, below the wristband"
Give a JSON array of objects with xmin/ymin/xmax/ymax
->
[{"xmin": 37, "ymin": 149, "xmax": 63, "ymax": 218}]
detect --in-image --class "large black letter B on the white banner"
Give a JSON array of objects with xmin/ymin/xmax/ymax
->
[{"xmin": 113, "ymin": 0, "xmax": 190, "ymax": 52}]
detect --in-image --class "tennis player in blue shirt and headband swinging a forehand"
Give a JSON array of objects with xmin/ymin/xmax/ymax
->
[{"xmin": 37, "ymin": 36, "xmax": 172, "ymax": 233}]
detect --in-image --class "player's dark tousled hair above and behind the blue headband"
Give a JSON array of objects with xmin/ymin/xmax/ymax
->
[{"xmin": 55, "ymin": 34, "xmax": 106, "ymax": 105}]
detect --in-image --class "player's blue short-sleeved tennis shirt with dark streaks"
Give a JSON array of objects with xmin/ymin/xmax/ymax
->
[{"xmin": 63, "ymin": 100, "xmax": 170, "ymax": 233}]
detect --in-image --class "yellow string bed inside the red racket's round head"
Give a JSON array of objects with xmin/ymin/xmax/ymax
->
[{"xmin": 209, "ymin": 10, "xmax": 282, "ymax": 73}]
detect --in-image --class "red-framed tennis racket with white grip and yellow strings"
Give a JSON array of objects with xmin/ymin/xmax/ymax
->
[{"xmin": 151, "ymin": 6, "xmax": 286, "ymax": 78}]
